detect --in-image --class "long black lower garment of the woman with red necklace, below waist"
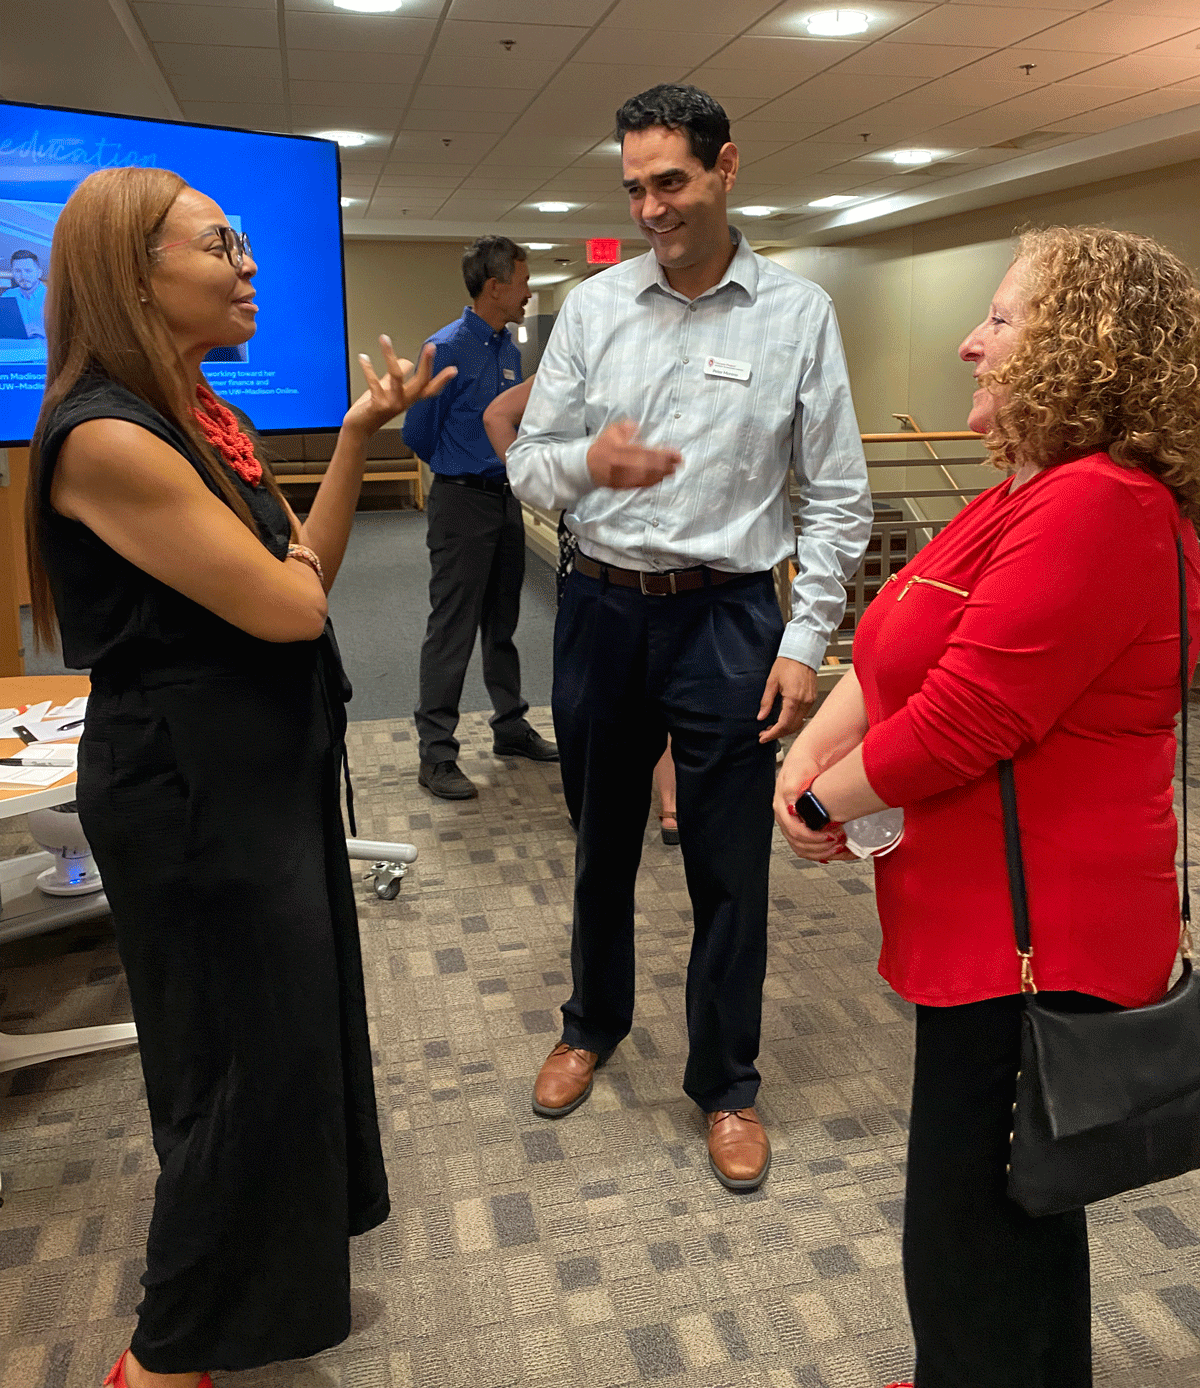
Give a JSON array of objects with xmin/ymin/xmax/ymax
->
[{"xmin": 78, "ymin": 637, "xmax": 388, "ymax": 1373}]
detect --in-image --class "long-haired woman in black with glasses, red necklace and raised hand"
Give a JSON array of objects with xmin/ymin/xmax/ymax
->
[{"xmin": 28, "ymin": 169, "xmax": 452, "ymax": 1388}]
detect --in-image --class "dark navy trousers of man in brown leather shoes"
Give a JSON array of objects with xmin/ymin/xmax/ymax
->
[{"xmin": 554, "ymin": 557, "xmax": 782, "ymax": 1112}]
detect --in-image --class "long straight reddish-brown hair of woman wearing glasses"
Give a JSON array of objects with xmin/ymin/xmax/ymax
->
[{"xmin": 25, "ymin": 168, "xmax": 282, "ymax": 648}]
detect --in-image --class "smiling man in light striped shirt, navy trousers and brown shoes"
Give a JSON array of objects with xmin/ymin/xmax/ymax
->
[{"xmin": 508, "ymin": 86, "xmax": 871, "ymax": 1190}]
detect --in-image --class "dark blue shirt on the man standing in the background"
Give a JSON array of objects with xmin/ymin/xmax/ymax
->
[{"xmin": 404, "ymin": 305, "xmax": 522, "ymax": 477}]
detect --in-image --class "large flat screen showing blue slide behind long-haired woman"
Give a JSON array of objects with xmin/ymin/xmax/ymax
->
[{"xmin": 0, "ymin": 101, "xmax": 350, "ymax": 447}]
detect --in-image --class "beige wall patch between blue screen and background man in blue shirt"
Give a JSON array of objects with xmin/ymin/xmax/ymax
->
[{"xmin": 345, "ymin": 240, "xmax": 468, "ymax": 421}]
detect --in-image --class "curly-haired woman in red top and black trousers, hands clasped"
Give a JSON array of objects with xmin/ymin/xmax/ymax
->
[{"xmin": 775, "ymin": 228, "xmax": 1200, "ymax": 1388}]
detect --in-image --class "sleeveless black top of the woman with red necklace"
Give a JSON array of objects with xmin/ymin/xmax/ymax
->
[{"xmin": 37, "ymin": 376, "xmax": 296, "ymax": 673}]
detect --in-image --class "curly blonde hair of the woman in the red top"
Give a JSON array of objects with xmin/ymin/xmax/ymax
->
[{"xmin": 981, "ymin": 226, "xmax": 1200, "ymax": 522}]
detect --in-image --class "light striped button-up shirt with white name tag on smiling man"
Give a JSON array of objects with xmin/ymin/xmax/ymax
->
[{"xmin": 508, "ymin": 232, "xmax": 873, "ymax": 668}]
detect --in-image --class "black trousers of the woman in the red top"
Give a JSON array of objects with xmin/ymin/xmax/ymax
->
[{"xmin": 903, "ymin": 992, "xmax": 1111, "ymax": 1388}]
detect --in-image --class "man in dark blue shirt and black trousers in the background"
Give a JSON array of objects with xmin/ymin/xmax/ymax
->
[{"xmin": 404, "ymin": 236, "xmax": 558, "ymax": 799}]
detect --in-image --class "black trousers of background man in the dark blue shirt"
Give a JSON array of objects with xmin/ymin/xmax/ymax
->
[{"xmin": 416, "ymin": 476, "xmax": 529, "ymax": 762}]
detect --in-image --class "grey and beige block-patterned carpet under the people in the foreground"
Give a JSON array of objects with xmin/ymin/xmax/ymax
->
[{"xmin": 0, "ymin": 709, "xmax": 1200, "ymax": 1388}]
